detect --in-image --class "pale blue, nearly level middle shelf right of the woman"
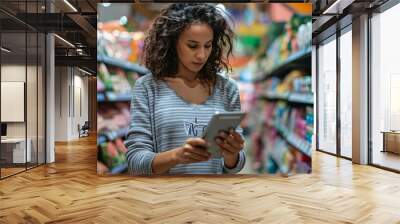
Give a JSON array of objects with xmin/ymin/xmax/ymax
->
[{"xmin": 262, "ymin": 92, "xmax": 314, "ymax": 105}]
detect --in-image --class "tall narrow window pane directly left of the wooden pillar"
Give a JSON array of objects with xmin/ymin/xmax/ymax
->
[{"xmin": 340, "ymin": 30, "xmax": 353, "ymax": 158}]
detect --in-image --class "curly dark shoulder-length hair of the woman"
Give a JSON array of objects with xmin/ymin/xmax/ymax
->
[{"xmin": 144, "ymin": 3, "xmax": 235, "ymax": 86}]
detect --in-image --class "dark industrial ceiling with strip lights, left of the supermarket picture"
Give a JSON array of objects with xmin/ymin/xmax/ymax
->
[{"xmin": 0, "ymin": 0, "xmax": 108, "ymax": 74}]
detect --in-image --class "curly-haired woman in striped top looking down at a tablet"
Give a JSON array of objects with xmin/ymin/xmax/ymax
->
[{"xmin": 126, "ymin": 3, "xmax": 245, "ymax": 175}]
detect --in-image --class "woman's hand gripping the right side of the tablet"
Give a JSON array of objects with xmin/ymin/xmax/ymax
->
[{"xmin": 215, "ymin": 129, "xmax": 244, "ymax": 168}]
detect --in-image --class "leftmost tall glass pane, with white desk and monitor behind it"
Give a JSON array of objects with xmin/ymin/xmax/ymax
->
[{"xmin": 0, "ymin": 14, "xmax": 27, "ymax": 177}]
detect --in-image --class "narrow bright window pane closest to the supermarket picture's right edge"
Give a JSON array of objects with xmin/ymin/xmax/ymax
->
[{"xmin": 318, "ymin": 39, "xmax": 336, "ymax": 154}]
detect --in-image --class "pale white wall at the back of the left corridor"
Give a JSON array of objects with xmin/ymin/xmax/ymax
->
[{"xmin": 55, "ymin": 67, "xmax": 88, "ymax": 141}]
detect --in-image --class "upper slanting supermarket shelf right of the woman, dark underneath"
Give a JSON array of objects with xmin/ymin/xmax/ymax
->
[{"xmin": 254, "ymin": 47, "xmax": 311, "ymax": 82}]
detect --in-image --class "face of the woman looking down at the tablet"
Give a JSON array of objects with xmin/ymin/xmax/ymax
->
[{"xmin": 176, "ymin": 23, "xmax": 214, "ymax": 73}]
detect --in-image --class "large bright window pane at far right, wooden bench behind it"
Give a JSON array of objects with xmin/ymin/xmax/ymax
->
[{"xmin": 371, "ymin": 5, "xmax": 400, "ymax": 170}]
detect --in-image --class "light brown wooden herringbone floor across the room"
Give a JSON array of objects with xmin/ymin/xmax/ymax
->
[{"xmin": 0, "ymin": 134, "xmax": 400, "ymax": 224}]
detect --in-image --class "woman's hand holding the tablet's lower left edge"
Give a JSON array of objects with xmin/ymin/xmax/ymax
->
[{"xmin": 173, "ymin": 138, "xmax": 211, "ymax": 164}]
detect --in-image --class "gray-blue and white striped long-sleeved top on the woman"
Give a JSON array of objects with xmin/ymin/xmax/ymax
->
[{"xmin": 125, "ymin": 74, "xmax": 245, "ymax": 175}]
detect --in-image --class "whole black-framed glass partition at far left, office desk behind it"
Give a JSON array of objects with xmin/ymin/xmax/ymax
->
[{"xmin": 0, "ymin": 1, "xmax": 46, "ymax": 179}]
